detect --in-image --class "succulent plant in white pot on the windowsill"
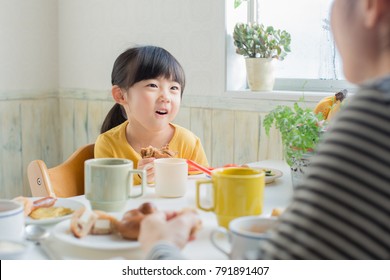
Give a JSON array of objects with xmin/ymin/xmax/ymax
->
[{"xmin": 233, "ymin": 23, "xmax": 291, "ymax": 91}]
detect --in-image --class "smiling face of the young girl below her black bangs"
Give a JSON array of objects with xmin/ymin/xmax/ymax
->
[{"xmin": 125, "ymin": 77, "xmax": 181, "ymax": 131}]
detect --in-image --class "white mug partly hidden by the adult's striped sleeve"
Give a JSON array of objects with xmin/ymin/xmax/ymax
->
[{"xmin": 210, "ymin": 216, "xmax": 277, "ymax": 260}]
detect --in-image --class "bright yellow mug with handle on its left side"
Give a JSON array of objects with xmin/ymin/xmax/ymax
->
[{"xmin": 196, "ymin": 167, "xmax": 265, "ymax": 228}]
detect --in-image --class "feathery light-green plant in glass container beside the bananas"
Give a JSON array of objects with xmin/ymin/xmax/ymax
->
[{"xmin": 263, "ymin": 102, "xmax": 325, "ymax": 186}]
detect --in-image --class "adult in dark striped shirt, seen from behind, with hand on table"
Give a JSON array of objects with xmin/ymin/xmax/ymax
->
[{"xmin": 140, "ymin": 0, "xmax": 390, "ymax": 259}]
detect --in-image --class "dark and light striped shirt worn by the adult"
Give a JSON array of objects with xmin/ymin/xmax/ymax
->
[{"xmin": 149, "ymin": 76, "xmax": 390, "ymax": 259}]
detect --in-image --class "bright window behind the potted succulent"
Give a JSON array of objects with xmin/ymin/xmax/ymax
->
[{"xmin": 226, "ymin": 0, "xmax": 353, "ymax": 91}]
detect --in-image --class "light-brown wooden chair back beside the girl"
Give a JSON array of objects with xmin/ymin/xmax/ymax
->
[{"xmin": 27, "ymin": 144, "xmax": 95, "ymax": 197}]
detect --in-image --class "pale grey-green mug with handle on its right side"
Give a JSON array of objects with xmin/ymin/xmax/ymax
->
[{"xmin": 84, "ymin": 158, "xmax": 147, "ymax": 212}]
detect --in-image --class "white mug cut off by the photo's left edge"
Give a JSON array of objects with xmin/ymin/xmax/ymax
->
[{"xmin": 0, "ymin": 199, "xmax": 24, "ymax": 240}]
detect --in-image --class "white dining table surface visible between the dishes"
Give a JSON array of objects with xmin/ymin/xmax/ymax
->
[{"xmin": 21, "ymin": 160, "xmax": 293, "ymax": 260}]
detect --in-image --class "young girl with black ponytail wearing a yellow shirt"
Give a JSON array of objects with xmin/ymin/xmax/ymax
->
[{"xmin": 95, "ymin": 46, "xmax": 208, "ymax": 184}]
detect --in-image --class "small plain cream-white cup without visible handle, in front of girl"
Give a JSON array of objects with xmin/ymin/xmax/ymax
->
[{"xmin": 154, "ymin": 158, "xmax": 188, "ymax": 197}]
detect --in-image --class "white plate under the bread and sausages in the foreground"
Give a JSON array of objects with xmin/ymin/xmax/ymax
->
[{"xmin": 53, "ymin": 220, "xmax": 140, "ymax": 250}]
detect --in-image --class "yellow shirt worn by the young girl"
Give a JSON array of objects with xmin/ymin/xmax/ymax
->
[{"xmin": 95, "ymin": 121, "xmax": 209, "ymax": 185}]
